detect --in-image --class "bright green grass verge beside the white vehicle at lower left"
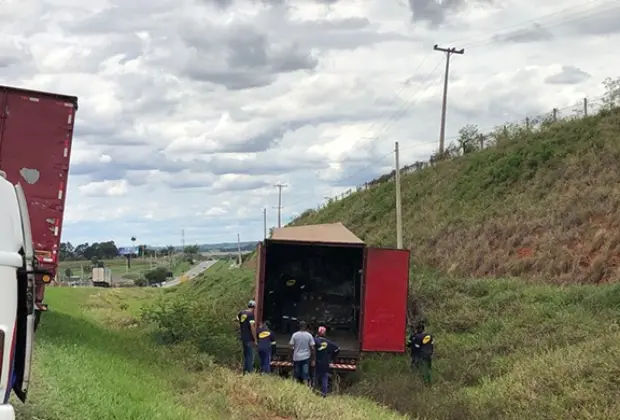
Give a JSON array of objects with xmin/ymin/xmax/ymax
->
[{"xmin": 16, "ymin": 270, "xmax": 406, "ymax": 420}]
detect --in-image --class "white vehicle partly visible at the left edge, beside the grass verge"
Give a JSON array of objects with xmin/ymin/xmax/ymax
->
[{"xmin": 0, "ymin": 171, "xmax": 36, "ymax": 420}]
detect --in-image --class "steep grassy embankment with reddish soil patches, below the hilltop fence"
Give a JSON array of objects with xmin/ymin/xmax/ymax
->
[{"xmin": 292, "ymin": 105, "xmax": 620, "ymax": 283}]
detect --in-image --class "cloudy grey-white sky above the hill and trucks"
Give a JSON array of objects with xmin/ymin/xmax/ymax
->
[{"xmin": 0, "ymin": 0, "xmax": 620, "ymax": 245}]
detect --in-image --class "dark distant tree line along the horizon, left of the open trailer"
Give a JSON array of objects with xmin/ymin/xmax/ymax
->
[{"xmin": 59, "ymin": 241, "xmax": 200, "ymax": 261}]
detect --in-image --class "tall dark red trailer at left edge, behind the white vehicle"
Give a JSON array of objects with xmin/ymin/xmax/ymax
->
[{"xmin": 0, "ymin": 86, "xmax": 78, "ymax": 321}]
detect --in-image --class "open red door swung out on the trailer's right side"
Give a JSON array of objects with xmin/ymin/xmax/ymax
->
[{"xmin": 362, "ymin": 248, "xmax": 409, "ymax": 353}]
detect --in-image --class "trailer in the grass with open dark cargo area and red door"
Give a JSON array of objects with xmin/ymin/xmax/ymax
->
[{"xmin": 255, "ymin": 223, "xmax": 410, "ymax": 372}]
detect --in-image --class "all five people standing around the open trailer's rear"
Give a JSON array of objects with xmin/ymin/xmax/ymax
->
[{"xmin": 236, "ymin": 300, "xmax": 434, "ymax": 397}]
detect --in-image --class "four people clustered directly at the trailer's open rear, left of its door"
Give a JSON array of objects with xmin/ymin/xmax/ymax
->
[{"xmin": 236, "ymin": 300, "xmax": 340, "ymax": 397}]
